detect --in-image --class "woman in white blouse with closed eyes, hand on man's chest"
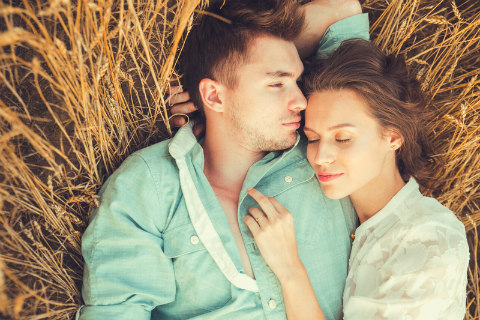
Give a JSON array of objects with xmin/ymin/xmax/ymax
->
[{"xmin": 245, "ymin": 40, "xmax": 469, "ymax": 320}]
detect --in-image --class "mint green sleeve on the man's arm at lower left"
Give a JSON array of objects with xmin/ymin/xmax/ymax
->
[{"xmin": 77, "ymin": 155, "xmax": 175, "ymax": 320}]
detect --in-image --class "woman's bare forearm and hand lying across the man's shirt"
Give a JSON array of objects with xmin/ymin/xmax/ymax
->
[{"xmin": 245, "ymin": 189, "xmax": 325, "ymax": 320}]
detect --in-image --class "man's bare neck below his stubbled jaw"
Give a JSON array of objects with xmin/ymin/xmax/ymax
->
[{"xmin": 203, "ymin": 125, "xmax": 266, "ymax": 195}]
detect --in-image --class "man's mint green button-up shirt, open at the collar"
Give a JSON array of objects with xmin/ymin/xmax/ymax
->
[{"xmin": 77, "ymin": 14, "xmax": 368, "ymax": 320}]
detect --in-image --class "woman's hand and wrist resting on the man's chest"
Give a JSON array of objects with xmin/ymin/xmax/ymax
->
[{"xmin": 245, "ymin": 189, "xmax": 303, "ymax": 282}]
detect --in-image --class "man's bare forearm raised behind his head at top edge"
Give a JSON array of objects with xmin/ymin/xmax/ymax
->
[{"xmin": 294, "ymin": 0, "xmax": 362, "ymax": 59}]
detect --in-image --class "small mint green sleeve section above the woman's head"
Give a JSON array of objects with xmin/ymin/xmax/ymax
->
[{"xmin": 316, "ymin": 13, "xmax": 370, "ymax": 58}]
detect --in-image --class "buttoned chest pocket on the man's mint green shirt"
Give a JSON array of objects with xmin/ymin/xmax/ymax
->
[{"xmin": 163, "ymin": 224, "xmax": 231, "ymax": 316}]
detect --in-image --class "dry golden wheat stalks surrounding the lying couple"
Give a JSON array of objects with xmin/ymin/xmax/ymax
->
[{"xmin": 0, "ymin": 0, "xmax": 480, "ymax": 319}]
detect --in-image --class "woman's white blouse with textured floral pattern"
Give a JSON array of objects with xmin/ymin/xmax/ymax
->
[{"xmin": 343, "ymin": 178, "xmax": 469, "ymax": 320}]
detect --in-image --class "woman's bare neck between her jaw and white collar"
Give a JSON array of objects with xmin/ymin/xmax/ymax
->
[{"xmin": 350, "ymin": 166, "xmax": 405, "ymax": 223}]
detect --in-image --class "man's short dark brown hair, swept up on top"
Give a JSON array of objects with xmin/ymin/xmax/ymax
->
[{"xmin": 180, "ymin": 0, "xmax": 304, "ymax": 115}]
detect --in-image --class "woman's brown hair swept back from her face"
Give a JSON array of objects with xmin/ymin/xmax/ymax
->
[{"xmin": 304, "ymin": 39, "xmax": 431, "ymax": 186}]
